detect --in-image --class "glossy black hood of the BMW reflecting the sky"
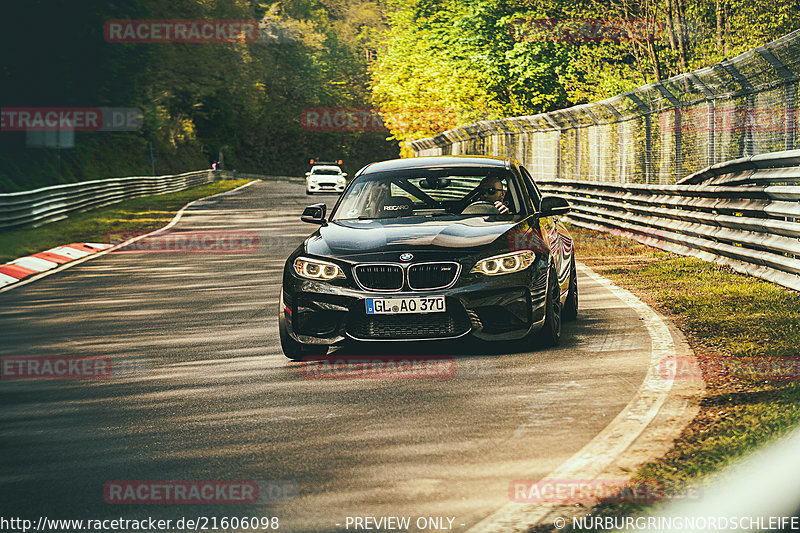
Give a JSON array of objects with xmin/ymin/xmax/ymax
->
[{"xmin": 305, "ymin": 216, "xmax": 520, "ymax": 256}]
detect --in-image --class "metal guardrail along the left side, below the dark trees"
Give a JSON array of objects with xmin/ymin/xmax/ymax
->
[{"xmin": 0, "ymin": 170, "xmax": 234, "ymax": 230}]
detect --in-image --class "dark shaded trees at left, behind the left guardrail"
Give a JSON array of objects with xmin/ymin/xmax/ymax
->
[{"xmin": 0, "ymin": 0, "xmax": 397, "ymax": 192}]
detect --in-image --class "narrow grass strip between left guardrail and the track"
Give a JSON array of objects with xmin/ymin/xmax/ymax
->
[{"xmin": 0, "ymin": 180, "xmax": 252, "ymax": 264}]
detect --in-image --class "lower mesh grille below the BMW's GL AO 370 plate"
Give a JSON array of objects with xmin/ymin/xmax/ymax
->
[{"xmin": 347, "ymin": 312, "xmax": 470, "ymax": 340}]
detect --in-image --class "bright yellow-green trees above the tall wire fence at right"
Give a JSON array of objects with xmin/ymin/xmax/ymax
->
[{"xmin": 372, "ymin": 0, "xmax": 798, "ymax": 150}]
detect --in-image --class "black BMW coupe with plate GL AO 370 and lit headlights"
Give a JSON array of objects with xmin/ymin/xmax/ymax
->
[{"xmin": 278, "ymin": 156, "xmax": 578, "ymax": 359}]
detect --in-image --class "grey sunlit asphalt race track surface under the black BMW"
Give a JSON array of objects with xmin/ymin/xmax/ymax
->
[{"xmin": 0, "ymin": 182, "xmax": 668, "ymax": 532}]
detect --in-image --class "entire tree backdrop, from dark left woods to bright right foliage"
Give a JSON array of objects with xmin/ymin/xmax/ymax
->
[{"xmin": 0, "ymin": 0, "xmax": 797, "ymax": 191}]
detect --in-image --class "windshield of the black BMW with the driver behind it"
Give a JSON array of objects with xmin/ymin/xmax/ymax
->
[{"xmin": 331, "ymin": 167, "xmax": 522, "ymax": 220}]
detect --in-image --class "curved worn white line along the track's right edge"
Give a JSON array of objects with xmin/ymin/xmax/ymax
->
[{"xmin": 468, "ymin": 263, "xmax": 677, "ymax": 533}]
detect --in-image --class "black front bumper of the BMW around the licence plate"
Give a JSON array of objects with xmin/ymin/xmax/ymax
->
[{"xmin": 280, "ymin": 267, "xmax": 547, "ymax": 345}]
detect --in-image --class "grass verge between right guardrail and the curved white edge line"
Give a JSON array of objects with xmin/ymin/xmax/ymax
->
[{"xmin": 570, "ymin": 226, "xmax": 800, "ymax": 516}]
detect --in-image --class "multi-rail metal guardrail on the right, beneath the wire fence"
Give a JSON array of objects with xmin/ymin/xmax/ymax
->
[{"xmin": 537, "ymin": 150, "xmax": 800, "ymax": 290}]
